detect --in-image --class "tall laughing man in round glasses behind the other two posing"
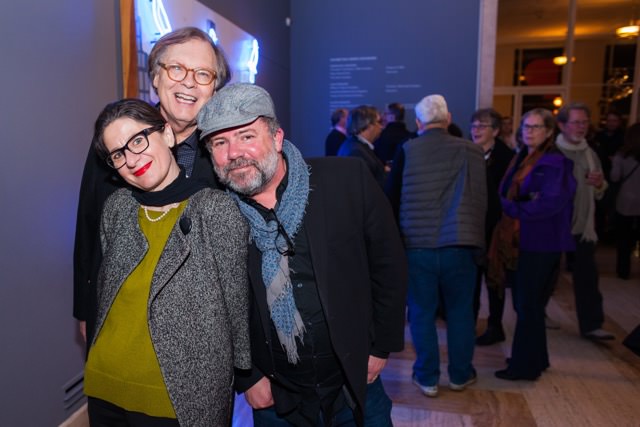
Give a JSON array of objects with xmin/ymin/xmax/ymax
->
[{"xmin": 73, "ymin": 27, "xmax": 231, "ymax": 352}]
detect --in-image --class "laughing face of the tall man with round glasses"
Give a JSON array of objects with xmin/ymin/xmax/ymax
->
[{"xmin": 153, "ymin": 39, "xmax": 217, "ymax": 142}]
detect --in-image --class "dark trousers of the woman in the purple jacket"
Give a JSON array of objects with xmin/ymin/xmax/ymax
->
[{"xmin": 509, "ymin": 251, "xmax": 560, "ymax": 379}]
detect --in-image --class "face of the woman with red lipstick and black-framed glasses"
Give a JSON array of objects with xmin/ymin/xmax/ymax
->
[{"xmin": 103, "ymin": 117, "xmax": 180, "ymax": 191}]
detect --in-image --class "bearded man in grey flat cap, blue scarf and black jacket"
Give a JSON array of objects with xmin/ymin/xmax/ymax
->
[{"xmin": 198, "ymin": 83, "xmax": 407, "ymax": 426}]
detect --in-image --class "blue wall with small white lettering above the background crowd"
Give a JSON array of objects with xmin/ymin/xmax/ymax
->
[{"xmin": 289, "ymin": 0, "xmax": 479, "ymax": 156}]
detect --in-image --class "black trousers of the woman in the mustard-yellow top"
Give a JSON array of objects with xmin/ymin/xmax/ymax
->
[{"xmin": 87, "ymin": 397, "xmax": 180, "ymax": 427}]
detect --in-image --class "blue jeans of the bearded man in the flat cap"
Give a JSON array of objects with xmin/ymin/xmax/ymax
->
[{"xmin": 253, "ymin": 377, "xmax": 393, "ymax": 427}]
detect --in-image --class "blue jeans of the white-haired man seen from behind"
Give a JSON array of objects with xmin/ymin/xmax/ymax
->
[{"xmin": 407, "ymin": 247, "xmax": 478, "ymax": 386}]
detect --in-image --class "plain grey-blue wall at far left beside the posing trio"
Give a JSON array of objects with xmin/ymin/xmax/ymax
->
[{"xmin": 0, "ymin": 0, "xmax": 118, "ymax": 427}]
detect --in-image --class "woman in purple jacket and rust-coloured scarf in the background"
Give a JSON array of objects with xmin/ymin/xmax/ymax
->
[{"xmin": 489, "ymin": 108, "xmax": 576, "ymax": 380}]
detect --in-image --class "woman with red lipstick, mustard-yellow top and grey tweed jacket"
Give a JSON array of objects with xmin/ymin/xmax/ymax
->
[{"xmin": 84, "ymin": 99, "xmax": 250, "ymax": 427}]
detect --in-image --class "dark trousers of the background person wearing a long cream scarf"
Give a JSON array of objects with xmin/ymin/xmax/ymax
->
[{"xmin": 572, "ymin": 235, "xmax": 604, "ymax": 335}]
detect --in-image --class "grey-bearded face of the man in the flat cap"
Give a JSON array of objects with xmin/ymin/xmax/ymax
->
[{"xmin": 207, "ymin": 119, "xmax": 284, "ymax": 196}]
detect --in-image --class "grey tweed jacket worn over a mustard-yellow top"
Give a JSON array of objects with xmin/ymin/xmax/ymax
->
[{"xmin": 94, "ymin": 188, "xmax": 251, "ymax": 427}]
